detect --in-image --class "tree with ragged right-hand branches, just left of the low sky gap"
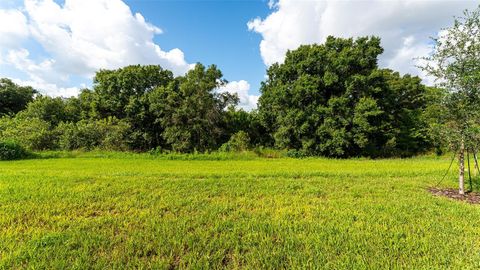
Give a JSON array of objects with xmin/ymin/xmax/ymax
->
[{"xmin": 149, "ymin": 64, "xmax": 238, "ymax": 152}]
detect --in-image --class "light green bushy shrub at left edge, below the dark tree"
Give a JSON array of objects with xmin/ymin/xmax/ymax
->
[{"xmin": 0, "ymin": 116, "xmax": 57, "ymax": 150}]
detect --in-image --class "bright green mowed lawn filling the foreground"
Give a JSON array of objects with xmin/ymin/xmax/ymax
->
[{"xmin": 0, "ymin": 155, "xmax": 480, "ymax": 269}]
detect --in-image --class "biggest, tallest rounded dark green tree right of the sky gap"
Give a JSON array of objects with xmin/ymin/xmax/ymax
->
[{"xmin": 259, "ymin": 37, "xmax": 432, "ymax": 157}]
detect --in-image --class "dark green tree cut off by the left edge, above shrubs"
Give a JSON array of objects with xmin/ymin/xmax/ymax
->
[{"xmin": 0, "ymin": 78, "xmax": 37, "ymax": 116}]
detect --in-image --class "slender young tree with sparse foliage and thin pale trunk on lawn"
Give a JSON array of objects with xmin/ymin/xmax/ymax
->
[{"xmin": 423, "ymin": 7, "xmax": 480, "ymax": 194}]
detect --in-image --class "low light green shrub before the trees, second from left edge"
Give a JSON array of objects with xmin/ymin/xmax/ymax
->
[{"xmin": 57, "ymin": 117, "xmax": 130, "ymax": 151}]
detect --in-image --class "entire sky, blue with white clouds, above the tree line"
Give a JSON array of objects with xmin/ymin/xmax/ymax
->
[{"xmin": 0, "ymin": 0, "xmax": 480, "ymax": 109}]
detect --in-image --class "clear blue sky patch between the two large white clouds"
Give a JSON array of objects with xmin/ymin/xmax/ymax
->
[{"xmin": 126, "ymin": 0, "xmax": 270, "ymax": 88}]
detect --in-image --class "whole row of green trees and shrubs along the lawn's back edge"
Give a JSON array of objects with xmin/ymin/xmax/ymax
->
[{"xmin": 0, "ymin": 37, "xmax": 458, "ymax": 157}]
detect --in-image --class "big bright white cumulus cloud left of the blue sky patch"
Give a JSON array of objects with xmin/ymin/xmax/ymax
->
[{"xmin": 0, "ymin": 0, "xmax": 193, "ymax": 96}]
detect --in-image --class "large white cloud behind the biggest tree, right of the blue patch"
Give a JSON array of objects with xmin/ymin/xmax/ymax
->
[{"xmin": 248, "ymin": 0, "xmax": 478, "ymax": 83}]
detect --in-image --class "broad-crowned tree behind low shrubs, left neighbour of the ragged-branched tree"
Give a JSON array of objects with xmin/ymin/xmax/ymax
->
[{"xmin": 92, "ymin": 65, "xmax": 174, "ymax": 149}]
